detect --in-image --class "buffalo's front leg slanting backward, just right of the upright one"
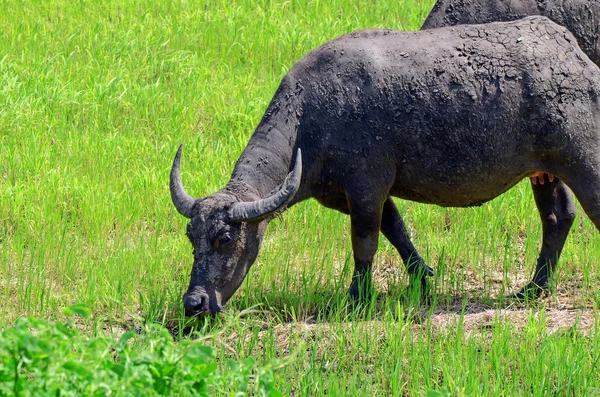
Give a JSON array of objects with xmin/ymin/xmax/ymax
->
[{"xmin": 381, "ymin": 197, "xmax": 433, "ymax": 295}]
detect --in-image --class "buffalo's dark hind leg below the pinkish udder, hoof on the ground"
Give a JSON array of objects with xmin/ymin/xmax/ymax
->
[{"xmin": 512, "ymin": 177, "xmax": 576, "ymax": 299}]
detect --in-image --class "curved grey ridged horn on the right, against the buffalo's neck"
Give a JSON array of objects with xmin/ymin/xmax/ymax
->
[{"xmin": 229, "ymin": 149, "xmax": 302, "ymax": 222}]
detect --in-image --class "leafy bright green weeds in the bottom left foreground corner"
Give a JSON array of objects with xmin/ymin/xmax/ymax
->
[{"xmin": 0, "ymin": 306, "xmax": 282, "ymax": 397}]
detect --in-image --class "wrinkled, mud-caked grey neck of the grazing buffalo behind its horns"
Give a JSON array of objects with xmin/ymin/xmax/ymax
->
[{"xmin": 228, "ymin": 81, "xmax": 298, "ymax": 198}]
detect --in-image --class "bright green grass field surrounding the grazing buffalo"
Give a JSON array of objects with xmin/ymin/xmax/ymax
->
[{"xmin": 0, "ymin": 0, "xmax": 600, "ymax": 396}]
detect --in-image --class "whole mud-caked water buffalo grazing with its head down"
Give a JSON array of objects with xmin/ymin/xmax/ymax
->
[{"xmin": 170, "ymin": 17, "xmax": 600, "ymax": 315}]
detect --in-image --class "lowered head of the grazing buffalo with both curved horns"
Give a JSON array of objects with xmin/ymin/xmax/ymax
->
[{"xmin": 170, "ymin": 146, "xmax": 302, "ymax": 315}]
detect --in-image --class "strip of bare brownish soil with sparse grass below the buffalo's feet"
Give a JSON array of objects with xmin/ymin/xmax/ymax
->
[{"xmin": 221, "ymin": 297, "xmax": 598, "ymax": 357}]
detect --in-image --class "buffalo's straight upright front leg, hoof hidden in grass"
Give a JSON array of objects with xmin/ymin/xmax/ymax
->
[{"xmin": 348, "ymin": 198, "xmax": 382, "ymax": 300}]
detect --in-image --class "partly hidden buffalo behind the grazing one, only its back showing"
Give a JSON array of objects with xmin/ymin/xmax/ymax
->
[{"xmin": 421, "ymin": 0, "xmax": 600, "ymax": 65}]
